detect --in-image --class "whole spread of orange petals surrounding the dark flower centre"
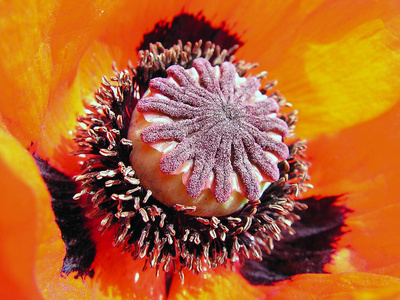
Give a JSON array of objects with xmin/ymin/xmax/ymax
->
[{"xmin": 0, "ymin": 0, "xmax": 400, "ymax": 299}]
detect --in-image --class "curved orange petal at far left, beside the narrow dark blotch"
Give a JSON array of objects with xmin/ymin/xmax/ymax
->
[{"xmin": 0, "ymin": 129, "xmax": 49, "ymax": 299}]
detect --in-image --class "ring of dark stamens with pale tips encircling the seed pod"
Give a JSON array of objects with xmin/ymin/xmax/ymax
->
[{"xmin": 74, "ymin": 41, "xmax": 310, "ymax": 276}]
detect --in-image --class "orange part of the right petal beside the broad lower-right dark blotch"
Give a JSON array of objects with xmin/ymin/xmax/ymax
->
[{"xmin": 308, "ymin": 103, "xmax": 400, "ymax": 276}]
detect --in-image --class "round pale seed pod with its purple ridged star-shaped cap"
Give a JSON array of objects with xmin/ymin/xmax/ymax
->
[{"xmin": 128, "ymin": 58, "xmax": 289, "ymax": 216}]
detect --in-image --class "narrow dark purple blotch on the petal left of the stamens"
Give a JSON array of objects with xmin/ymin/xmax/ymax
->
[{"xmin": 34, "ymin": 155, "xmax": 96, "ymax": 278}]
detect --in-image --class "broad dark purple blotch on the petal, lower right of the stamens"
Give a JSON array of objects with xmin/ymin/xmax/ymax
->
[{"xmin": 240, "ymin": 196, "xmax": 350, "ymax": 285}]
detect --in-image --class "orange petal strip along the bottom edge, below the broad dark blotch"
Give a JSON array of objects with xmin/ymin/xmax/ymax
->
[{"xmin": 169, "ymin": 269, "xmax": 400, "ymax": 300}]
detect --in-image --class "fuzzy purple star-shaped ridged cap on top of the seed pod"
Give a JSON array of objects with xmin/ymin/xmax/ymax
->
[{"xmin": 138, "ymin": 58, "xmax": 289, "ymax": 203}]
